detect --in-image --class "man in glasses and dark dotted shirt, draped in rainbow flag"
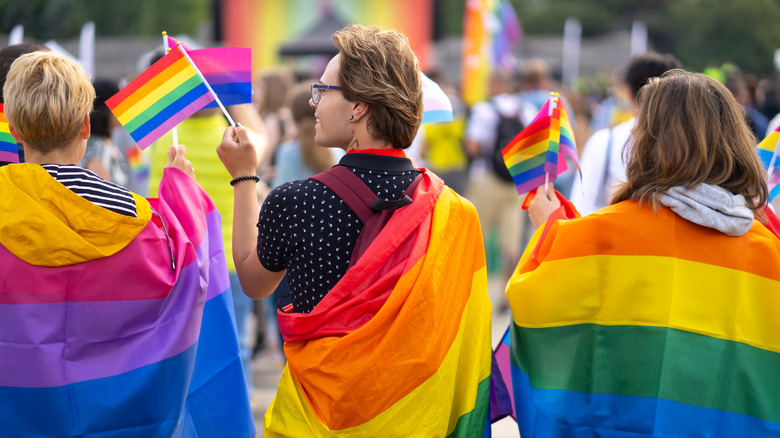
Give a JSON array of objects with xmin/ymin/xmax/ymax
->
[{"xmin": 217, "ymin": 25, "xmax": 491, "ymax": 437}]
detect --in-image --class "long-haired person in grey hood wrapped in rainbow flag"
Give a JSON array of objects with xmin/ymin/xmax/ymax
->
[{"xmin": 506, "ymin": 70, "xmax": 780, "ymax": 437}]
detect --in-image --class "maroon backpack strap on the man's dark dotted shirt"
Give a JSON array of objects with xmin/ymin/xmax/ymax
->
[{"xmin": 309, "ymin": 165, "xmax": 422, "ymax": 267}]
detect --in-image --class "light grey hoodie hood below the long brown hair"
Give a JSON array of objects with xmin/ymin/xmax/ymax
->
[{"xmin": 661, "ymin": 184, "xmax": 753, "ymax": 236}]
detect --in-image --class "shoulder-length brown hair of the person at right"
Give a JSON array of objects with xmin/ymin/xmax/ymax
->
[{"xmin": 612, "ymin": 70, "xmax": 767, "ymax": 211}]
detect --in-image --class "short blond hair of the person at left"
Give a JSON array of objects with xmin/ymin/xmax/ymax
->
[{"xmin": 3, "ymin": 52, "xmax": 95, "ymax": 153}]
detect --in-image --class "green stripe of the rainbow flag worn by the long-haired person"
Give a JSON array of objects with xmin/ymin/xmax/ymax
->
[{"xmin": 510, "ymin": 324, "xmax": 780, "ymax": 422}]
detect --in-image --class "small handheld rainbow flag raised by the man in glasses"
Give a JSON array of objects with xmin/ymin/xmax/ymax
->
[{"xmin": 106, "ymin": 50, "xmax": 214, "ymax": 149}]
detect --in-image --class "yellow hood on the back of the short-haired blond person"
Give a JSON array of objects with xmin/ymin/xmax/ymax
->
[{"xmin": 0, "ymin": 163, "xmax": 151, "ymax": 266}]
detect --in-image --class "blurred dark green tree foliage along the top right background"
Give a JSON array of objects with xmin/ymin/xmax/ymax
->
[{"xmin": 435, "ymin": 0, "xmax": 780, "ymax": 73}]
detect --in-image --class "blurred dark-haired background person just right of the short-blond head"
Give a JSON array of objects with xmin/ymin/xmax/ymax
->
[{"xmin": 79, "ymin": 79, "xmax": 131, "ymax": 187}]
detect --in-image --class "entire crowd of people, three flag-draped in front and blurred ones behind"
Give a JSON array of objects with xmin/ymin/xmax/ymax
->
[{"xmin": 0, "ymin": 25, "xmax": 780, "ymax": 437}]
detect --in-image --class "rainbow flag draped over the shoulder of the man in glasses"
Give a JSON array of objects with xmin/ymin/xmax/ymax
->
[{"xmin": 264, "ymin": 172, "xmax": 492, "ymax": 437}]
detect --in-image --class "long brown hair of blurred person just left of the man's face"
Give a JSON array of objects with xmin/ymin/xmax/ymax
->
[{"xmin": 287, "ymin": 82, "xmax": 336, "ymax": 173}]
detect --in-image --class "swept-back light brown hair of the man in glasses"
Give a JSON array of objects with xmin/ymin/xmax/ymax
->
[{"xmin": 333, "ymin": 24, "xmax": 423, "ymax": 149}]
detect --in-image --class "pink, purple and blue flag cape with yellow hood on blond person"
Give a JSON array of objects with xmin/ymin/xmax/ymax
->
[{"xmin": 0, "ymin": 164, "xmax": 255, "ymax": 437}]
